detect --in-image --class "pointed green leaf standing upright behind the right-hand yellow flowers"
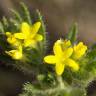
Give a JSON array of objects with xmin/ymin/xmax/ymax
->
[{"xmin": 67, "ymin": 23, "xmax": 78, "ymax": 43}]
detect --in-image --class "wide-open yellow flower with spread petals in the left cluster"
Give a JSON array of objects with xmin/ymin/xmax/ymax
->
[{"xmin": 14, "ymin": 22, "xmax": 43, "ymax": 47}]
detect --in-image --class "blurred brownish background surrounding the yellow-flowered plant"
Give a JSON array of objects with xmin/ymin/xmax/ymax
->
[{"xmin": 0, "ymin": 0, "xmax": 96, "ymax": 96}]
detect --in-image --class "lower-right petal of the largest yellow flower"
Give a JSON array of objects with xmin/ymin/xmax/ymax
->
[{"xmin": 65, "ymin": 59, "xmax": 79, "ymax": 71}]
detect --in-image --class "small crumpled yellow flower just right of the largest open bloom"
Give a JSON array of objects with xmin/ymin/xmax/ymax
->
[{"xmin": 73, "ymin": 42, "xmax": 87, "ymax": 59}]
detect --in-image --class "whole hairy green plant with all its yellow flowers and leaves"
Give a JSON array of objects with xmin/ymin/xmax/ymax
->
[{"xmin": 0, "ymin": 3, "xmax": 96, "ymax": 96}]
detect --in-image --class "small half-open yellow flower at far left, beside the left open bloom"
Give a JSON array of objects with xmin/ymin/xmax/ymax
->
[{"xmin": 6, "ymin": 32, "xmax": 20, "ymax": 46}]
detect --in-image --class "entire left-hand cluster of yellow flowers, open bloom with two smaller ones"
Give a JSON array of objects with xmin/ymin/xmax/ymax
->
[{"xmin": 5, "ymin": 22, "xmax": 43, "ymax": 60}]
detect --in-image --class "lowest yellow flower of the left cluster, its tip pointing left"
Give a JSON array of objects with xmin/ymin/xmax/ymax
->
[{"xmin": 5, "ymin": 46, "xmax": 23, "ymax": 60}]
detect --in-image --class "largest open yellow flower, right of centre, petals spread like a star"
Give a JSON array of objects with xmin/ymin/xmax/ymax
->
[{"xmin": 44, "ymin": 40, "xmax": 79, "ymax": 75}]
